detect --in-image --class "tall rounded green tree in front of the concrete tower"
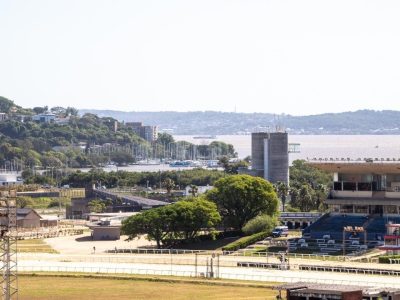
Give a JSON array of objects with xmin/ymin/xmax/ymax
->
[{"xmin": 207, "ymin": 175, "xmax": 278, "ymax": 230}]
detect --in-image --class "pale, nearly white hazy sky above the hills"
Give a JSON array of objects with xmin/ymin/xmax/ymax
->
[{"xmin": 0, "ymin": 0, "xmax": 400, "ymax": 115}]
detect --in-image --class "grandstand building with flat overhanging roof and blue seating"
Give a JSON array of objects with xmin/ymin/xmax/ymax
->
[{"xmin": 303, "ymin": 159, "xmax": 400, "ymax": 241}]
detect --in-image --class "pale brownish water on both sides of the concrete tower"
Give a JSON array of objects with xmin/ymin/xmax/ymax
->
[{"xmin": 174, "ymin": 134, "xmax": 400, "ymax": 161}]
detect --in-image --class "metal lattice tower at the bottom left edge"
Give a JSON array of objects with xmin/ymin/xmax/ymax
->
[{"xmin": 0, "ymin": 191, "xmax": 18, "ymax": 300}]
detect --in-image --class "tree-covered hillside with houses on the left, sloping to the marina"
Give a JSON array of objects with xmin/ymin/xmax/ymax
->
[{"xmin": 0, "ymin": 96, "xmax": 235, "ymax": 171}]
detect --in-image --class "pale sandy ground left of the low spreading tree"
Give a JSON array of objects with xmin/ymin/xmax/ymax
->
[{"xmin": 44, "ymin": 232, "xmax": 154, "ymax": 254}]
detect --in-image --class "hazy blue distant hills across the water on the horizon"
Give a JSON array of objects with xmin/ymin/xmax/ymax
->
[{"xmin": 79, "ymin": 109, "xmax": 400, "ymax": 134}]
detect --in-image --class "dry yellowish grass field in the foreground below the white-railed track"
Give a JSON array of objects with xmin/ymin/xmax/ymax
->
[{"xmin": 18, "ymin": 275, "xmax": 277, "ymax": 300}]
